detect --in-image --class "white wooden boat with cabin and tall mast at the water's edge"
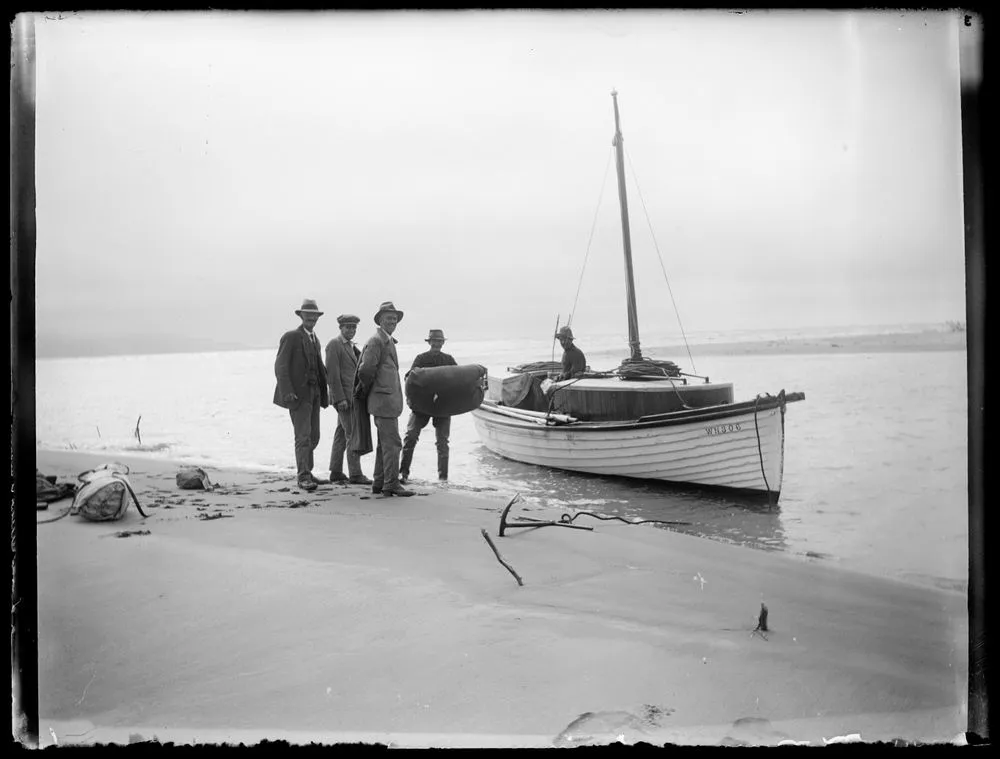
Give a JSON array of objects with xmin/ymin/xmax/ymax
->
[{"xmin": 472, "ymin": 92, "xmax": 805, "ymax": 502}]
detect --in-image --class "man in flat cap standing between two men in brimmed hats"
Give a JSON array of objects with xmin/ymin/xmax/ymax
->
[{"xmin": 326, "ymin": 314, "xmax": 372, "ymax": 485}]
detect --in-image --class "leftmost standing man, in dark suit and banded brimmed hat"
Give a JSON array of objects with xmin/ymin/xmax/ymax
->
[{"xmin": 274, "ymin": 299, "xmax": 330, "ymax": 491}]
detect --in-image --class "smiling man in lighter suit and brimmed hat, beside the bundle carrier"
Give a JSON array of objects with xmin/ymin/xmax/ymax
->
[{"xmin": 357, "ymin": 301, "xmax": 416, "ymax": 496}]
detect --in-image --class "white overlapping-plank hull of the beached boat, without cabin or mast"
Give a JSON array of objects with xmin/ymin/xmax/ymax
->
[{"xmin": 472, "ymin": 396, "xmax": 785, "ymax": 499}]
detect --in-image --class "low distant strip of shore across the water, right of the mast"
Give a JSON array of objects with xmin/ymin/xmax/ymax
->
[{"xmin": 644, "ymin": 330, "xmax": 966, "ymax": 356}]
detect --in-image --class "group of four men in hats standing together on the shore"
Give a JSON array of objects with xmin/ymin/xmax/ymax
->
[{"xmin": 274, "ymin": 299, "xmax": 456, "ymax": 496}]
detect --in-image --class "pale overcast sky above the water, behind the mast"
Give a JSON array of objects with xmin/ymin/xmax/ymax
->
[{"xmin": 36, "ymin": 11, "xmax": 965, "ymax": 356}]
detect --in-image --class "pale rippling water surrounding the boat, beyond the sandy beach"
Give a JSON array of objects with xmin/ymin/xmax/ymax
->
[{"xmin": 36, "ymin": 326, "xmax": 968, "ymax": 590}]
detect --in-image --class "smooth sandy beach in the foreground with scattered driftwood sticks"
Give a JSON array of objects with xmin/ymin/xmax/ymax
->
[{"xmin": 38, "ymin": 451, "xmax": 968, "ymax": 747}]
